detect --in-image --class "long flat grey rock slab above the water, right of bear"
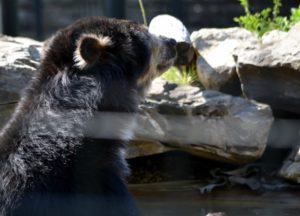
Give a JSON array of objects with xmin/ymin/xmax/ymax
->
[{"xmin": 136, "ymin": 79, "xmax": 273, "ymax": 163}]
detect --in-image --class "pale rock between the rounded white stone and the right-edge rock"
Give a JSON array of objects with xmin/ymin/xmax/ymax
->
[{"xmin": 191, "ymin": 28, "xmax": 258, "ymax": 95}]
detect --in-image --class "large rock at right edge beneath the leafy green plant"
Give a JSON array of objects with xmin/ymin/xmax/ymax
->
[{"xmin": 237, "ymin": 23, "xmax": 300, "ymax": 115}]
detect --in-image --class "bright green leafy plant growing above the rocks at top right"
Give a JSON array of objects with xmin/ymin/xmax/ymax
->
[{"xmin": 234, "ymin": 0, "xmax": 300, "ymax": 37}]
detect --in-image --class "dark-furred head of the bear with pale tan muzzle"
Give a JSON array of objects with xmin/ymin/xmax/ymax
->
[{"xmin": 42, "ymin": 17, "xmax": 176, "ymax": 94}]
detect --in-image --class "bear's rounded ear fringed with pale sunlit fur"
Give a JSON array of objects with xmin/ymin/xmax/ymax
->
[{"xmin": 74, "ymin": 34, "xmax": 112, "ymax": 69}]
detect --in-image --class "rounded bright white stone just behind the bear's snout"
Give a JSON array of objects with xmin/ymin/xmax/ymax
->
[{"xmin": 149, "ymin": 14, "xmax": 196, "ymax": 66}]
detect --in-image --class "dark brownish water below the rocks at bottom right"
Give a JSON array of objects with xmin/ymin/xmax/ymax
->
[{"xmin": 130, "ymin": 182, "xmax": 300, "ymax": 216}]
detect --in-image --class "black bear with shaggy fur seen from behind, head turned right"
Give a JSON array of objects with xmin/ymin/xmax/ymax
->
[{"xmin": 0, "ymin": 17, "xmax": 176, "ymax": 216}]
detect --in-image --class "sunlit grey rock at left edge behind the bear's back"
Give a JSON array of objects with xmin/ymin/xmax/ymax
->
[{"xmin": 0, "ymin": 36, "xmax": 42, "ymax": 128}]
